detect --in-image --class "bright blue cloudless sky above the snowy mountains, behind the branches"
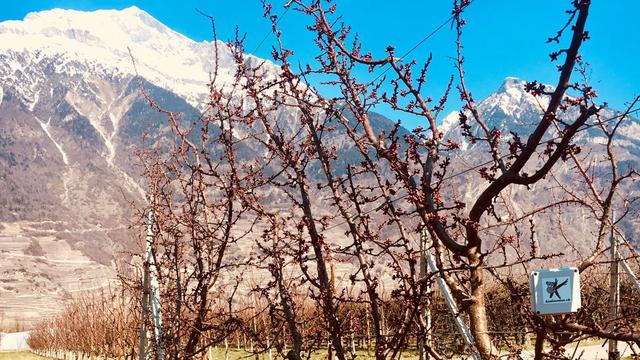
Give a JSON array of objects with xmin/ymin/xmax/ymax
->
[{"xmin": 0, "ymin": 0, "xmax": 640, "ymax": 127}]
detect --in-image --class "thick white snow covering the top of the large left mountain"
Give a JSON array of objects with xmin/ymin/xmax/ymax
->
[{"xmin": 0, "ymin": 6, "xmax": 266, "ymax": 107}]
